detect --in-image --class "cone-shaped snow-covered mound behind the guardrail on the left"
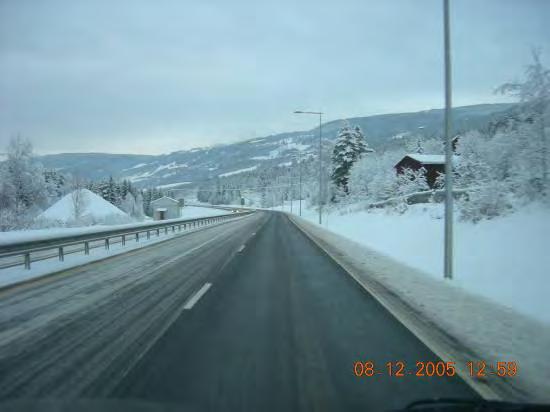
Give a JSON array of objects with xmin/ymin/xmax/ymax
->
[{"xmin": 36, "ymin": 189, "xmax": 132, "ymax": 226}]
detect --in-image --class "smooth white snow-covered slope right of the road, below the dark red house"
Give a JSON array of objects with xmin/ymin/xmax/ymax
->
[{"xmin": 279, "ymin": 202, "xmax": 550, "ymax": 323}]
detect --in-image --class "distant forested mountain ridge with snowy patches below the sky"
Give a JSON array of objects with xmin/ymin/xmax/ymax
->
[{"xmin": 39, "ymin": 103, "xmax": 514, "ymax": 187}]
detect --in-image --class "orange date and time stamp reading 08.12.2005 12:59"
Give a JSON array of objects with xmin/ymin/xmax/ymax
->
[{"xmin": 353, "ymin": 360, "xmax": 518, "ymax": 378}]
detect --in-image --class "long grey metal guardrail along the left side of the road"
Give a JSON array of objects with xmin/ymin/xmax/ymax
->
[{"xmin": 0, "ymin": 211, "xmax": 253, "ymax": 269}]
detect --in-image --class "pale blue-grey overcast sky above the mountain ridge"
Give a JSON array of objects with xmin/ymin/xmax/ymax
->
[{"xmin": 0, "ymin": 0, "xmax": 550, "ymax": 154}]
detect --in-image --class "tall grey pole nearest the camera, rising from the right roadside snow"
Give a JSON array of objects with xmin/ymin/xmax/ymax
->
[{"xmin": 443, "ymin": 0, "xmax": 453, "ymax": 279}]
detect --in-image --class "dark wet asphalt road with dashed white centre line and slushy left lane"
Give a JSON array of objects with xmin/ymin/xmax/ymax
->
[{"xmin": 0, "ymin": 212, "xmax": 478, "ymax": 411}]
